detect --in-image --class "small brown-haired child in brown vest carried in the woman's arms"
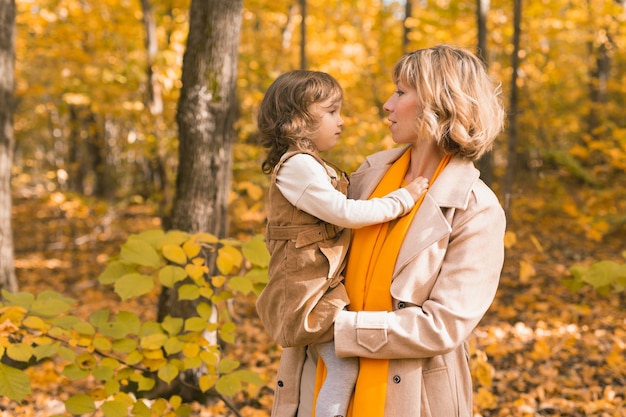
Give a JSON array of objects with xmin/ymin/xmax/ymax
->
[{"xmin": 257, "ymin": 70, "xmax": 427, "ymax": 417}]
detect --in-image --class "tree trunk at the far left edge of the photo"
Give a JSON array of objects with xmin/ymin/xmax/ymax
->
[{"xmin": 0, "ymin": 0, "xmax": 18, "ymax": 292}]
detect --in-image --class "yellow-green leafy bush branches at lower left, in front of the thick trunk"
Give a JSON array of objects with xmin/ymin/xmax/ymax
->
[{"xmin": 0, "ymin": 230, "xmax": 269, "ymax": 417}]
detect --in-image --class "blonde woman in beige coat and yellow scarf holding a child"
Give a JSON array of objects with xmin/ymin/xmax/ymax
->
[{"xmin": 272, "ymin": 45, "xmax": 505, "ymax": 417}]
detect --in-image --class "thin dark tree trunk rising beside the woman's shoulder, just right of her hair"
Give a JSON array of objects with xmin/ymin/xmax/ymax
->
[{"xmin": 503, "ymin": 0, "xmax": 522, "ymax": 215}]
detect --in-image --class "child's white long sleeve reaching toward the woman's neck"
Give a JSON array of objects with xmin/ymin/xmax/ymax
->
[{"xmin": 276, "ymin": 153, "xmax": 415, "ymax": 229}]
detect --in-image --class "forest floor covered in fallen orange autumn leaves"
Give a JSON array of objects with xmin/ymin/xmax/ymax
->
[{"xmin": 0, "ymin": 180, "xmax": 626, "ymax": 417}]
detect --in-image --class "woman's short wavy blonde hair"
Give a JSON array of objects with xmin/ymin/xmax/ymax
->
[{"xmin": 393, "ymin": 45, "xmax": 505, "ymax": 160}]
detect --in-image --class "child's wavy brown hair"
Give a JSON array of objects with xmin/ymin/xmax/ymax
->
[{"xmin": 257, "ymin": 70, "xmax": 343, "ymax": 174}]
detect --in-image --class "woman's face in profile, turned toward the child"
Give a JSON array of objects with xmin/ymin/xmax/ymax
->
[{"xmin": 383, "ymin": 82, "xmax": 420, "ymax": 144}]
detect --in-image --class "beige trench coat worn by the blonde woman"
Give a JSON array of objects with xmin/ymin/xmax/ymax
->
[{"xmin": 272, "ymin": 148, "xmax": 505, "ymax": 417}]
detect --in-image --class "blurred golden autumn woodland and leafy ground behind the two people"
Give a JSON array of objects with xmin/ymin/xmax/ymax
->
[{"xmin": 0, "ymin": 0, "xmax": 626, "ymax": 417}]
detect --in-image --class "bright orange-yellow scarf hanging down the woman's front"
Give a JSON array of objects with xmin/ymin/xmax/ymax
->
[{"xmin": 313, "ymin": 148, "xmax": 451, "ymax": 417}]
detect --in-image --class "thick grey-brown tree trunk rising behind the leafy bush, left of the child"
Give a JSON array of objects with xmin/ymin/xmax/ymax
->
[{"xmin": 158, "ymin": 0, "xmax": 243, "ymax": 398}]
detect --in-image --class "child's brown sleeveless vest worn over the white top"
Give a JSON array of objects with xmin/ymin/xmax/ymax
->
[{"xmin": 256, "ymin": 151, "xmax": 350, "ymax": 347}]
